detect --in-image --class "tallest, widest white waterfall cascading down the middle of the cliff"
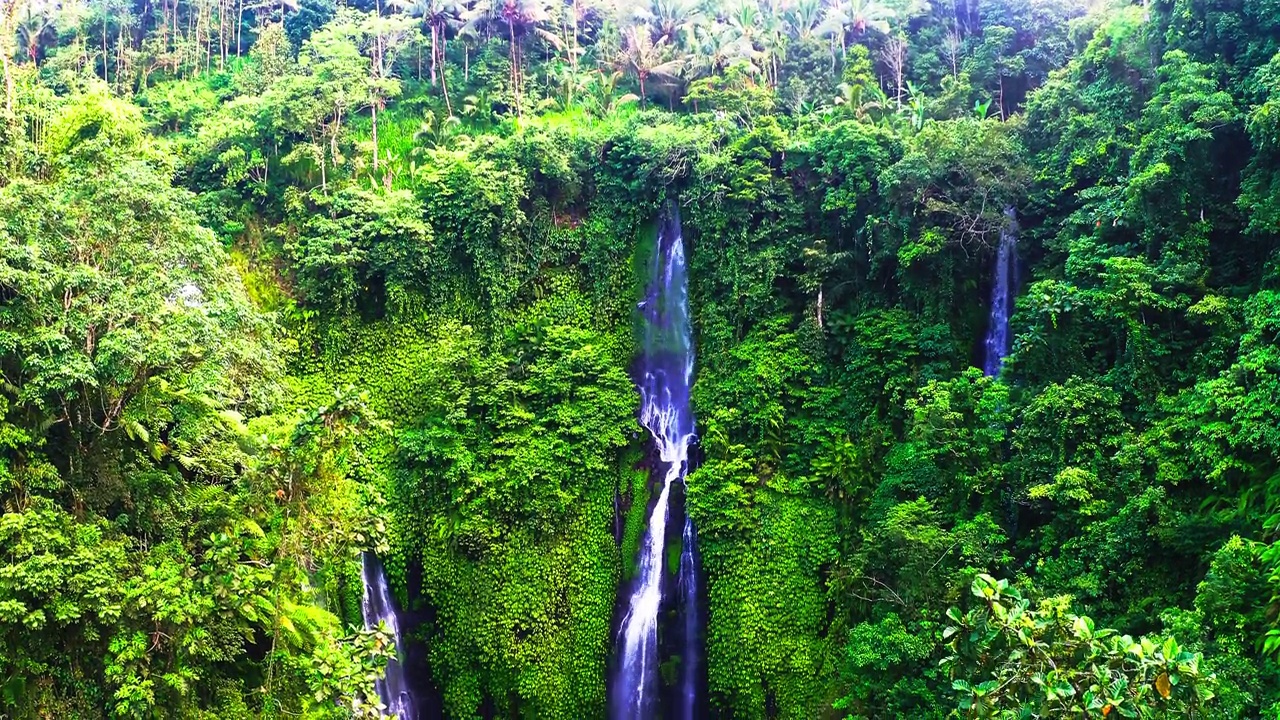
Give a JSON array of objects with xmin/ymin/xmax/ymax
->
[{"xmin": 609, "ymin": 208, "xmax": 704, "ymax": 720}]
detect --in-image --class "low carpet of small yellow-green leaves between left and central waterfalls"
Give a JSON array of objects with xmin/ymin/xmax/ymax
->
[{"xmin": 422, "ymin": 479, "xmax": 620, "ymax": 719}]
